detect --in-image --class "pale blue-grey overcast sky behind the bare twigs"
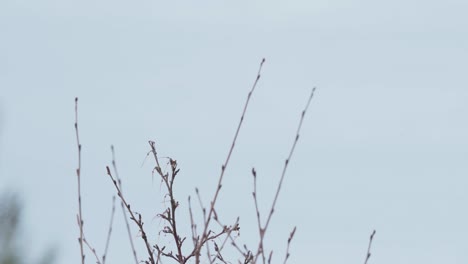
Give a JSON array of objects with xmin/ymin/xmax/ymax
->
[{"xmin": 0, "ymin": 0, "xmax": 468, "ymax": 264}]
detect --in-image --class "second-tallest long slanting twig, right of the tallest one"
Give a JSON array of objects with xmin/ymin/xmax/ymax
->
[{"xmin": 254, "ymin": 87, "xmax": 315, "ymax": 263}]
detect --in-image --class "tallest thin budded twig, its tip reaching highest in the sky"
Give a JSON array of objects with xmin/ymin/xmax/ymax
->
[{"xmin": 195, "ymin": 59, "xmax": 265, "ymax": 263}]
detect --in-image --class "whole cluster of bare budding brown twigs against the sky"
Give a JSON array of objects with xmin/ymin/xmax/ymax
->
[{"xmin": 71, "ymin": 59, "xmax": 375, "ymax": 264}]
